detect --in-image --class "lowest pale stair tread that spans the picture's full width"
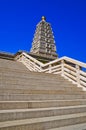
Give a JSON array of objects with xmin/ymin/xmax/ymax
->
[{"xmin": 0, "ymin": 113, "xmax": 86, "ymax": 128}]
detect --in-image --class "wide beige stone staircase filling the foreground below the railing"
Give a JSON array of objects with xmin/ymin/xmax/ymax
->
[{"xmin": 0, "ymin": 59, "xmax": 86, "ymax": 130}]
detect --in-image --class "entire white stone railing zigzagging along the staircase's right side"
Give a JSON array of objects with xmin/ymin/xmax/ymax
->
[{"xmin": 16, "ymin": 52, "xmax": 86, "ymax": 88}]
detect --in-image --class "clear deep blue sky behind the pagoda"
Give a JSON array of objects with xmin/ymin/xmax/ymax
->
[{"xmin": 0, "ymin": 0, "xmax": 86, "ymax": 62}]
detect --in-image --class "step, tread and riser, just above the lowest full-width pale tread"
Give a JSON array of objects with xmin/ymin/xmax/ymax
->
[{"xmin": 0, "ymin": 105, "xmax": 86, "ymax": 122}]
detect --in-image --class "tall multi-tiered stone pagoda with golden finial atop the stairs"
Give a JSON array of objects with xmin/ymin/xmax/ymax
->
[{"xmin": 30, "ymin": 16, "xmax": 57, "ymax": 59}]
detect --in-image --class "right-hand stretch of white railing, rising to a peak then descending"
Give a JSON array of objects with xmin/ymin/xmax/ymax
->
[{"xmin": 42, "ymin": 57, "xmax": 86, "ymax": 87}]
